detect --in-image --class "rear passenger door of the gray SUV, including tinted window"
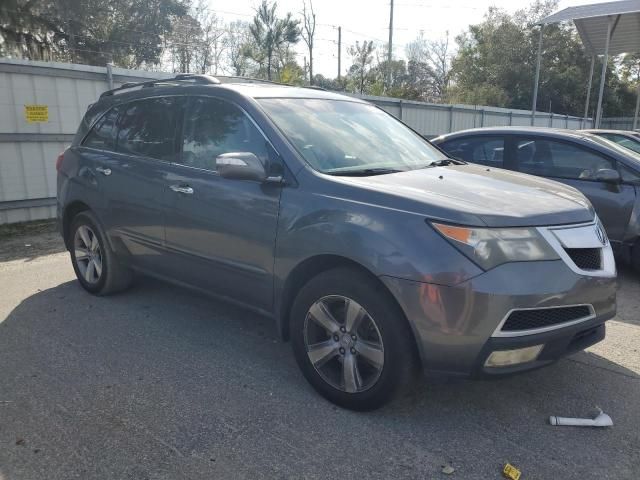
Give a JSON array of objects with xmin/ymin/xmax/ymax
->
[{"xmin": 83, "ymin": 97, "xmax": 177, "ymax": 271}]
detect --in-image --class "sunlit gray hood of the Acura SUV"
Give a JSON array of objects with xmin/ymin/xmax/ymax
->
[{"xmin": 342, "ymin": 164, "xmax": 594, "ymax": 227}]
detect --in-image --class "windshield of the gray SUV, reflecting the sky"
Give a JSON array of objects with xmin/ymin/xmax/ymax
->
[{"xmin": 259, "ymin": 98, "xmax": 447, "ymax": 175}]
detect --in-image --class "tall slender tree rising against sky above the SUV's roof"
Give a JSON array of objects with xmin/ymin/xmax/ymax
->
[{"xmin": 249, "ymin": 0, "xmax": 300, "ymax": 80}]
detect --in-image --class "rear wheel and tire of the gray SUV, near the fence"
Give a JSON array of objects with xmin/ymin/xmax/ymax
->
[{"xmin": 69, "ymin": 211, "xmax": 133, "ymax": 295}]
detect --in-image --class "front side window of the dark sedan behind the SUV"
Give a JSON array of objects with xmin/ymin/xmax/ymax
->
[{"xmin": 516, "ymin": 138, "xmax": 615, "ymax": 180}]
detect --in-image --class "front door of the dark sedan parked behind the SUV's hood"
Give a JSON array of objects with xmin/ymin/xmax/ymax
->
[{"xmin": 513, "ymin": 136, "xmax": 635, "ymax": 241}]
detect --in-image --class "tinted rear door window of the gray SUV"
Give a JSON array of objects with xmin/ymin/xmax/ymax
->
[{"xmin": 118, "ymin": 98, "xmax": 177, "ymax": 160}]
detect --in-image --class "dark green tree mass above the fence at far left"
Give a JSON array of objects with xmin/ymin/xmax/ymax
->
[{"xmin": 0, "ymin": 0, "xmax": 187, "ymax": 67}]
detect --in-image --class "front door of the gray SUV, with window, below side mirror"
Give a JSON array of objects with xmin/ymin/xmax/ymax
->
[{"xmin": 164, "ymin": 97, "xmax": 281, "ymax": 311}]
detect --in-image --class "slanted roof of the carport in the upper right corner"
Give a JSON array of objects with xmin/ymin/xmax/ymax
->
[{"xmin": 540, "ymin": 0, "xmax": 640, "ymax": 55}]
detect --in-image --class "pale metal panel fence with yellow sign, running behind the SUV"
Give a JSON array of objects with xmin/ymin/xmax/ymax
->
[{"xmin": 0, "ymin": 59, "xmax": 592, "ymax": 224}]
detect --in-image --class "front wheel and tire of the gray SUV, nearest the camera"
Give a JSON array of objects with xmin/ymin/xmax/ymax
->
[{"xmin": 290, "ymin": 268, "xmax": 417, "ymax": 411}]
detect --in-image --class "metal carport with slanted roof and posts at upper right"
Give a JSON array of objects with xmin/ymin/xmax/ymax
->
[{"xmin": 531, "ymin": 0, "xmax": 640, "ymax": 128}]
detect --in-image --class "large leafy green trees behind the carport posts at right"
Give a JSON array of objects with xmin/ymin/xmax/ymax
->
[{"xmin": 450, "ymin": 0, "xmax": 633, "ymax": 116}]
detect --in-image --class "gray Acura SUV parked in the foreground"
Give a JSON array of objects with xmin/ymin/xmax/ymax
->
[{"xmin": 57, "ymin": 75, "xmax": 616, "ymax": 410}]
